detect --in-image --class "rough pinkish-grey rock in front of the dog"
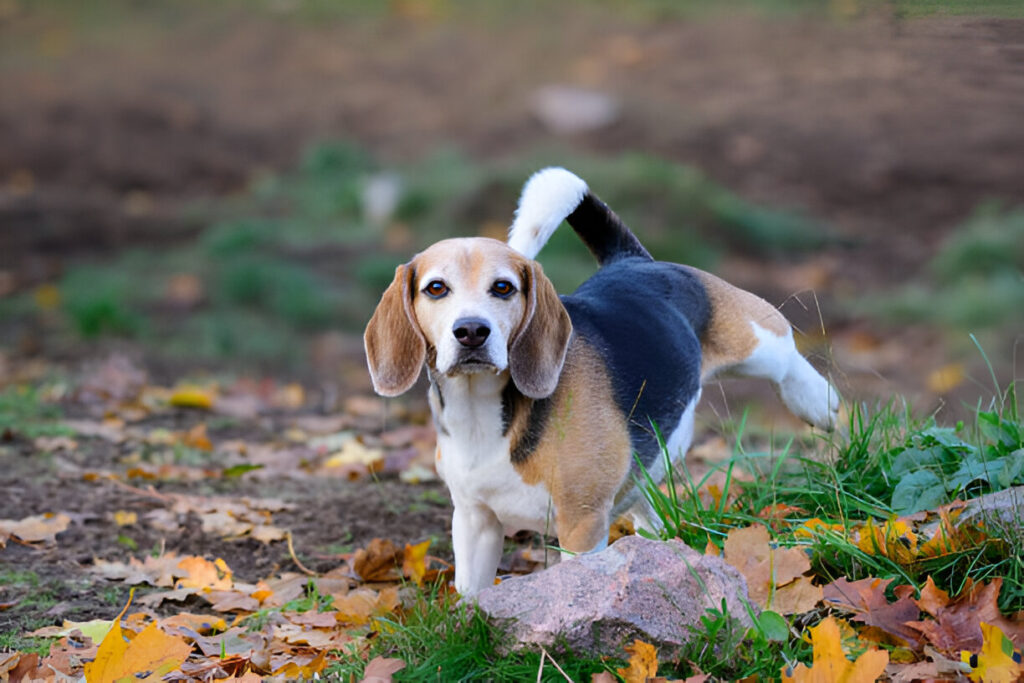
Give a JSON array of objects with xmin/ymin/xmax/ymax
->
[{"xmin": 478, "ymin": 536, "xmax": 751, "ymax": 655}]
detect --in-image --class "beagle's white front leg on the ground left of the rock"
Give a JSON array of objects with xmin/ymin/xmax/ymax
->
[{"xmin": 452, "ymin": 503, "xmax": 505, "ymax": 596}]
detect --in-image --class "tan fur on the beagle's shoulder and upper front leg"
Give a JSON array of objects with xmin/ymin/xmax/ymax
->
[{"xmin": 509, "ymin": 337, "xmax": 631, "ymax": 552}]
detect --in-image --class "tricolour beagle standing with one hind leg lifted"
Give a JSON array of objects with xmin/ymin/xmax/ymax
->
[{"xmin": 364, "ymin": 168, "xmax": 839, "ymax": 595}]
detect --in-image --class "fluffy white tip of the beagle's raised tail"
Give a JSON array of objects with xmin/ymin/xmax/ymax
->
[{"xmin": 508, "ymin": 167, "xmax": 587, "ymax": 258}]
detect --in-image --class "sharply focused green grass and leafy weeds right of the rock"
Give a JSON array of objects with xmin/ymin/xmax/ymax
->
[{"xmin": 614, "ymin": 389, "xmax": 1024, "ymax": 680}]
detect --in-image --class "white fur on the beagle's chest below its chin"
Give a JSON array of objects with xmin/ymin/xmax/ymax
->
[{"xmin": 430, "ymin": 373, "xmax": 554, "ymax": 533}]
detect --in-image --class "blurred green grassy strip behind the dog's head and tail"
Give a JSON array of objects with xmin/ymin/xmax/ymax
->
[{"xmin": 0, "ymin": 141, "xmax": 835, "ymax": 367}]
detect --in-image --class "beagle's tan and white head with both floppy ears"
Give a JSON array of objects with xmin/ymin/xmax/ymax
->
[{"xmin": 364, "ymin": 238, "xmax": 572, "ymax": 398}]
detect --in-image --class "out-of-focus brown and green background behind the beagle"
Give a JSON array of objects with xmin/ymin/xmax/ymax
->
[{"xmin": 0, "ymin": 0, "xmax": 1024, "ymax": 418}]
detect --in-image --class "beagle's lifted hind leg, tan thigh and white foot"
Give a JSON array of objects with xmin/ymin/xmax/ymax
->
[{"xmin": 691, "ymin": 268, "xmax": 840, "ymax": 429}]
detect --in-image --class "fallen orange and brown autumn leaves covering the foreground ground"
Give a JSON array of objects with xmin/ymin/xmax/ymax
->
[{"xmin": 0, "ymin": 352, "xmax": 1024, "ymax": 681}]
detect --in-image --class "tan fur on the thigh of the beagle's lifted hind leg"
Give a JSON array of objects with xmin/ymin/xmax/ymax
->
[{"xmin": 686, "ymin": 266, "xmax": 790, "ymax": 382}]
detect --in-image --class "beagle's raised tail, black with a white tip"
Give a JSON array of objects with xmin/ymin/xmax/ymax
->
[{"xmin": 509, "ymin": 168, "xmax": 653, "ymax": 265}]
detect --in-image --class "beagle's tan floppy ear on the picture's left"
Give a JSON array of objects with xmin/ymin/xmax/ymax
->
[{"xmin": 362, "ymin": 262, "xmax": 427, "ymax": 396}]
